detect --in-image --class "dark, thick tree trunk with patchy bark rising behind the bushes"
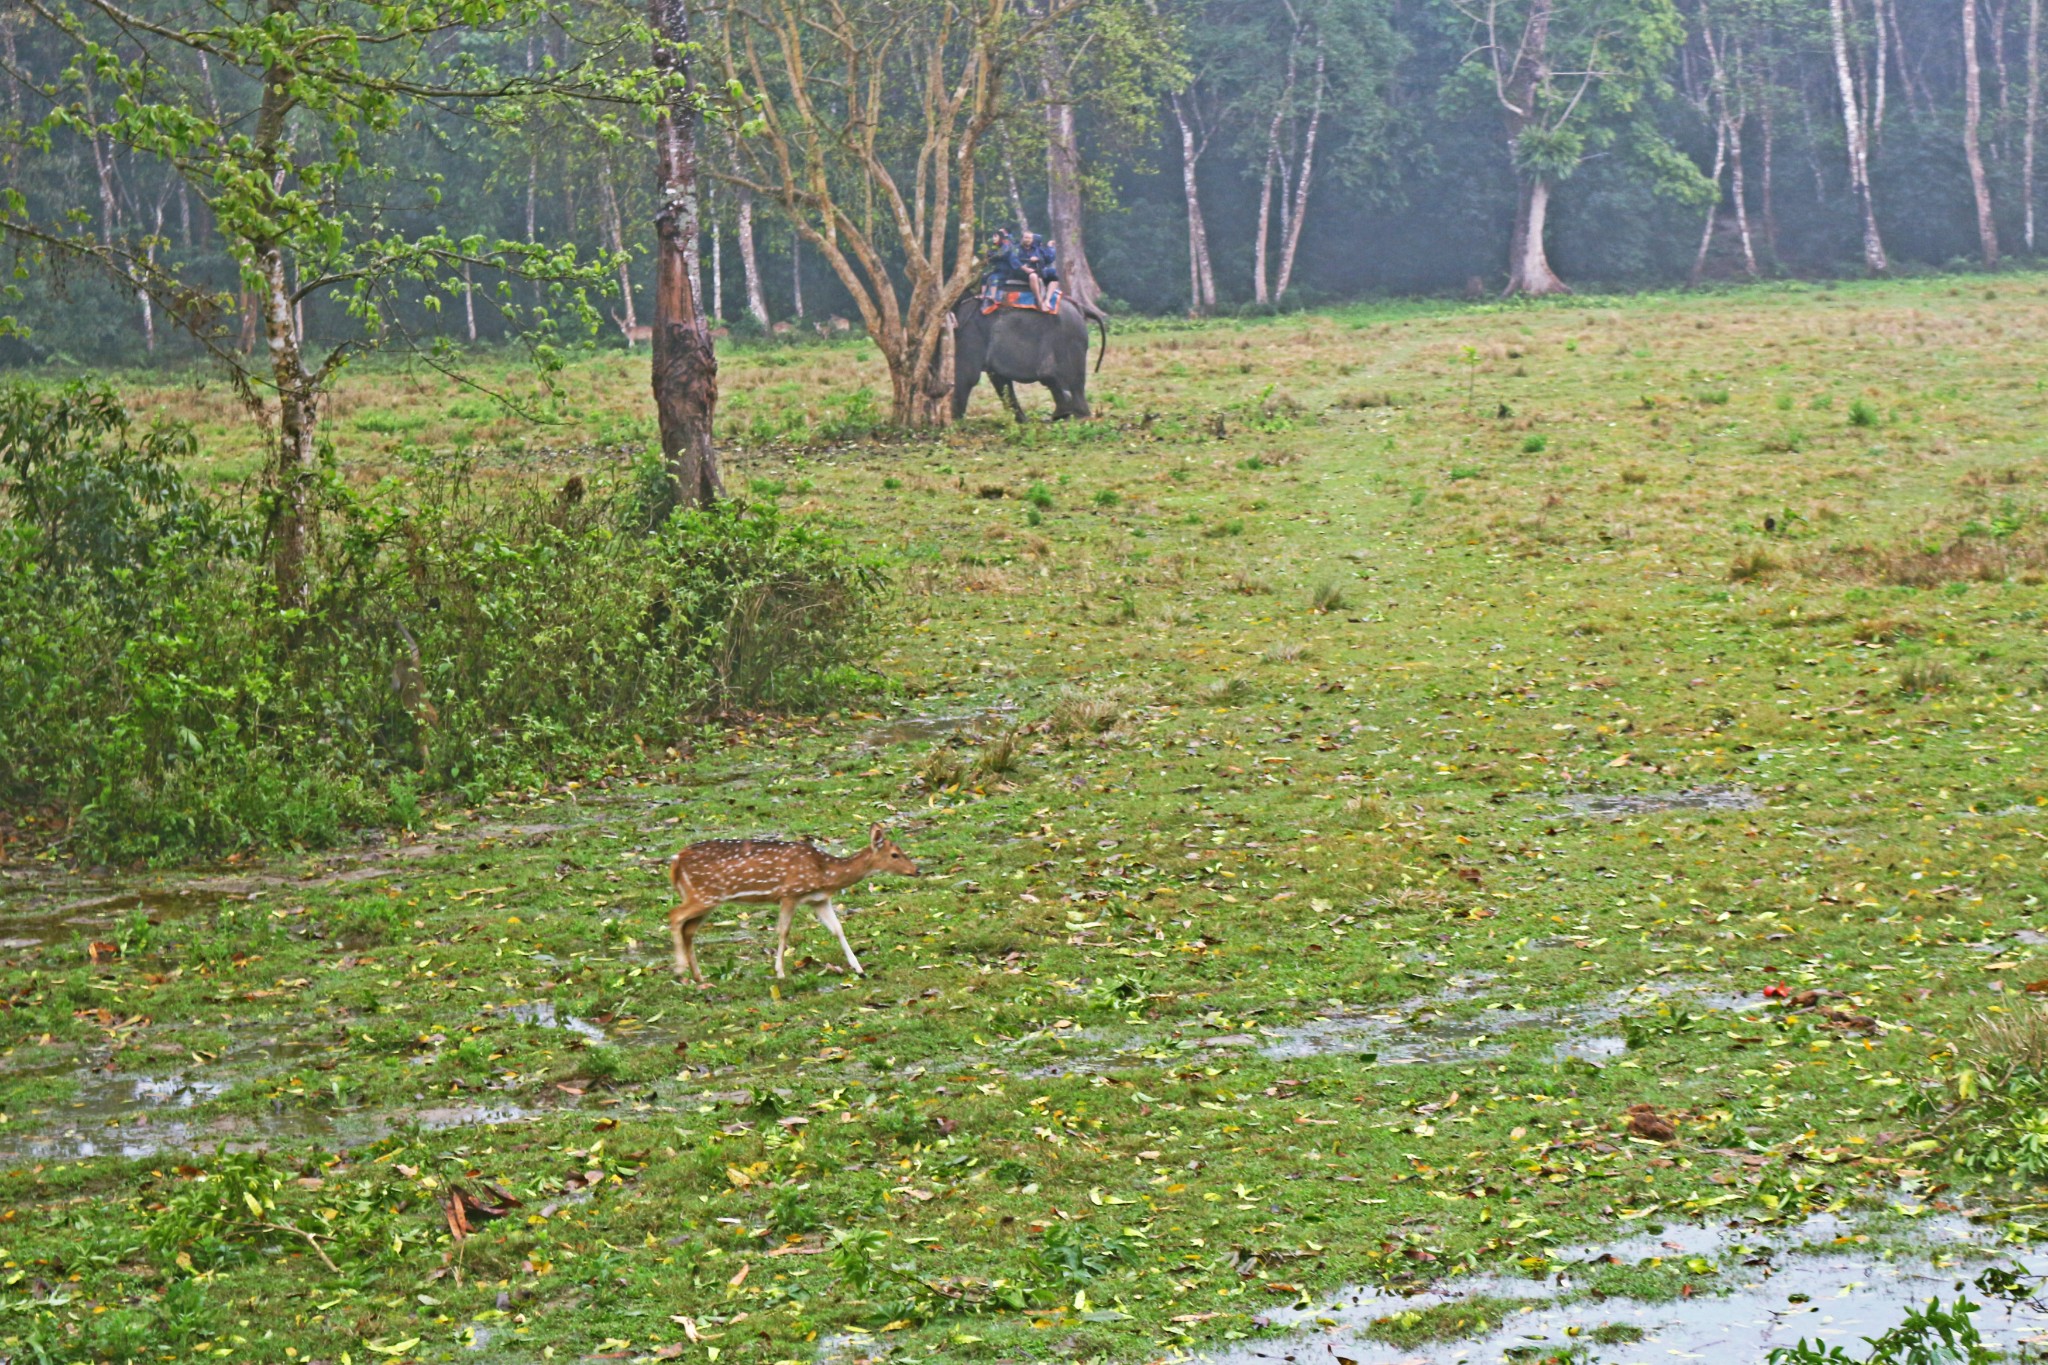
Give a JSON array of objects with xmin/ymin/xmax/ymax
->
[{"xmin": 647, "ymin": 0, "xmax": 723, "ymax": 508}]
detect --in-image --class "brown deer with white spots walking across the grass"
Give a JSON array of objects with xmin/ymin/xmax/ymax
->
[{"xmin": 668, "ymin": 825, "xmax": 918, "ymax": 984}]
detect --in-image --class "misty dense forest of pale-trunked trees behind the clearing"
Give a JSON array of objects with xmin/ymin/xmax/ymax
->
[{"xmin": 0, "ymin": 0, "xmax": 2040, "ymax": 364}]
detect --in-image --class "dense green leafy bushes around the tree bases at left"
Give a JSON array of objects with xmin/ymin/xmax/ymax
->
[{"xmin": 0, "ymin": 387, "xmax": 883, "ymax": 862}]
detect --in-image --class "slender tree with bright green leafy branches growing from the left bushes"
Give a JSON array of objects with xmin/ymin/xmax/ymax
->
[{"xmin": 0, "ymin": 0, "xmax": 600, "ymax": 606}]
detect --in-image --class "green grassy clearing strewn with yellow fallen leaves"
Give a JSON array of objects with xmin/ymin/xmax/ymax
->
[{"xmin": 0, "ymin": 276, "xmax": 2048, "ymax": 1365}]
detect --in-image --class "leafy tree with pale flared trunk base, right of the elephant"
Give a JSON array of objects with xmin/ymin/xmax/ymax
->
[{"xmin": 1446, "ymin": 0, "xmax": 1712, "ymax": 295}]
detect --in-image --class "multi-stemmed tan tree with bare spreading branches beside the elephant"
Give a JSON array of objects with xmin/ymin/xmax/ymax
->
[{"xmin": 711, "ymin": 0, "xmax": 1087, "ymax": 428}]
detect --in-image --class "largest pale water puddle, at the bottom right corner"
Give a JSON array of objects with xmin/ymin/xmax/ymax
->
[{"xmin": 1200, "ymin": 1218, "xmax": 2048, "ymax": 1365}]
